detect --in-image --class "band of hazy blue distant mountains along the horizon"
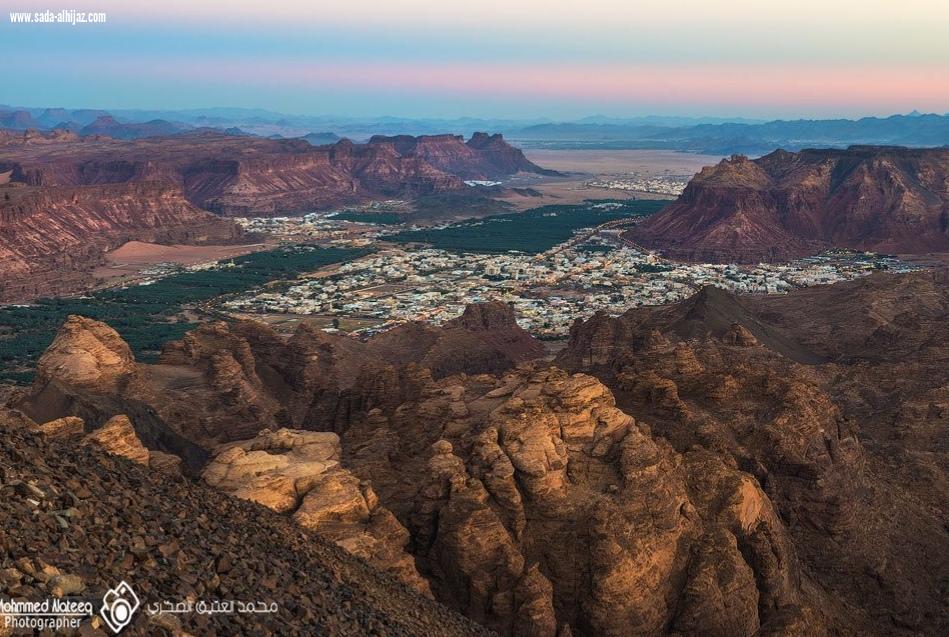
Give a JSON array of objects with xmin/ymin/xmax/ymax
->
[{"xmin": 0, "ymin": 105, "xmax": 949, "ymax": 155}]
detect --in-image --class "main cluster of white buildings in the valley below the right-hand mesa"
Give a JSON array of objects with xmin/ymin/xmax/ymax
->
[{"xmin": 219, "ymin": 220, "xmax": 915, "ymax": 339}]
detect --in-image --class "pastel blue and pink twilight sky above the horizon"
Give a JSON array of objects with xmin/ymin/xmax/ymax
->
[{"xmin": 0, "ymin": 0, "xmax": 949, "ymax": 119}]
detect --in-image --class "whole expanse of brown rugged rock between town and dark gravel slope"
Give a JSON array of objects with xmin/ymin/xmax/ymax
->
[{"xmin": 11, "ymin": 270, "xmax": 949, "ymax": 637}]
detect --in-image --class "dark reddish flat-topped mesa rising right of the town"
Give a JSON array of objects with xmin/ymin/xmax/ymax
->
[{"xmin": 628, "ymin": 146, "xmax": 949, "ymax": 262}]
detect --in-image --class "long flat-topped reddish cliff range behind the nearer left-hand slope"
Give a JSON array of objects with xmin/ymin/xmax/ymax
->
[{"xmin": 0, "ymin": 132, "xmax": 543, "ymax": 215}]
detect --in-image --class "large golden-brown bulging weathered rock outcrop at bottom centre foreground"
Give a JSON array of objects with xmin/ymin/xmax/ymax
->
[{"xmin": 328, "ymin": 369, "xmax": 828, "ymax": 636}]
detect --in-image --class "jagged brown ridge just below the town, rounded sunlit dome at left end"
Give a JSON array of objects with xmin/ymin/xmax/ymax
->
[{"xmin": 16, "ymin": 304, "xmax": 543, "ymax": 448}]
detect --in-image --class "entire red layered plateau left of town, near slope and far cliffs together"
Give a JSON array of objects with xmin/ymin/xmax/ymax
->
[{"xmin": 0, "ymin": 130, "xmax": 546, "ymax": 301}]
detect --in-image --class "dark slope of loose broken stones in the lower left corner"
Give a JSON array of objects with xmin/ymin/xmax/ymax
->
[{"xmin": 0, "ymin": 413, "xmax": 488, "ymax": 637}]
